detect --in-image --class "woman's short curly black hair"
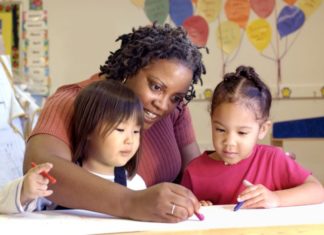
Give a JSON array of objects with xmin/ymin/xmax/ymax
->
[{"xmin": 100, "ymin": 23, "xmax": 206, "ymax": 102}]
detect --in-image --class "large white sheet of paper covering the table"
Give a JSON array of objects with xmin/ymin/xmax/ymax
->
[{"xmin": 0, "ymin": 204, "xmax": 324, "ymax": 234}]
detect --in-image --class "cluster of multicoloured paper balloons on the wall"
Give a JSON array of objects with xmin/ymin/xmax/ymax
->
[{"xmin": 131, "ymin": 0, "xmax": 322, "ymax": 96}]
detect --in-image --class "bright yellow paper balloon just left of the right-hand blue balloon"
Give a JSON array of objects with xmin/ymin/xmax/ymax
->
[{"xmin": 247, "ymin": 19, "xmax": 271, "ymax": 52}]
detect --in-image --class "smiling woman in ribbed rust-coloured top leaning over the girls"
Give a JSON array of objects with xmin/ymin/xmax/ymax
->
[{"xmin": 24, "ymin": 24, "xmax": 205, "ymax": 222}]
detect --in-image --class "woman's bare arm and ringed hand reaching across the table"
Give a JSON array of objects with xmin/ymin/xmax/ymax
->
[{"xmin": 24, "ymin": 134, "xmax": 199, "ymax": 222}]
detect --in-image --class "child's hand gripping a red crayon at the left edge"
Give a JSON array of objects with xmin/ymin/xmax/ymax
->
[{"xmin": 20, "ymin": 163, "xmax": 53, "ymax": 206}]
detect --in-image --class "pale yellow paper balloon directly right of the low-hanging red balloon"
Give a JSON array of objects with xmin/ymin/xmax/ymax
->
[{"xmin": 216, "ymin": 21, "xmax": 241, "ymax": 54}]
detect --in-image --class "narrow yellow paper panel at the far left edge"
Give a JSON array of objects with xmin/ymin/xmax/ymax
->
[{"xmin": 0, "ymin": 12, "xmax": 12, "ymax": 55}]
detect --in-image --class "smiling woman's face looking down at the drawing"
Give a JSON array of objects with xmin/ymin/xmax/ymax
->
[{"xmin": 126, "ymin": 60, "xmax": 193, "ymax": 129}]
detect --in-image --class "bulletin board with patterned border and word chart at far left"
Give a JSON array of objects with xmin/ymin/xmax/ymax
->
[{"xmin": 0, "ymin": 0, "xmax": 50, "ymax": 96}]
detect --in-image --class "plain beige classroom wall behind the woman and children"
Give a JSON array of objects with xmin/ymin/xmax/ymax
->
[{"xmin": 43, "ymin": 0, "xmax": 324, "ymax": 182}]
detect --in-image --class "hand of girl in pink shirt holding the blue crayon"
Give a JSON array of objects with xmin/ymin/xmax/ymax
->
[{"xmin": 237, "ymin": 184, "xmax": 279, "ymax": 208}]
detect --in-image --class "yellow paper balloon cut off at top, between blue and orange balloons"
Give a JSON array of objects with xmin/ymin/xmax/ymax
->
[{"xmin": 197, "ymin": 0, "xmax": 222, "ymax": 23}]
